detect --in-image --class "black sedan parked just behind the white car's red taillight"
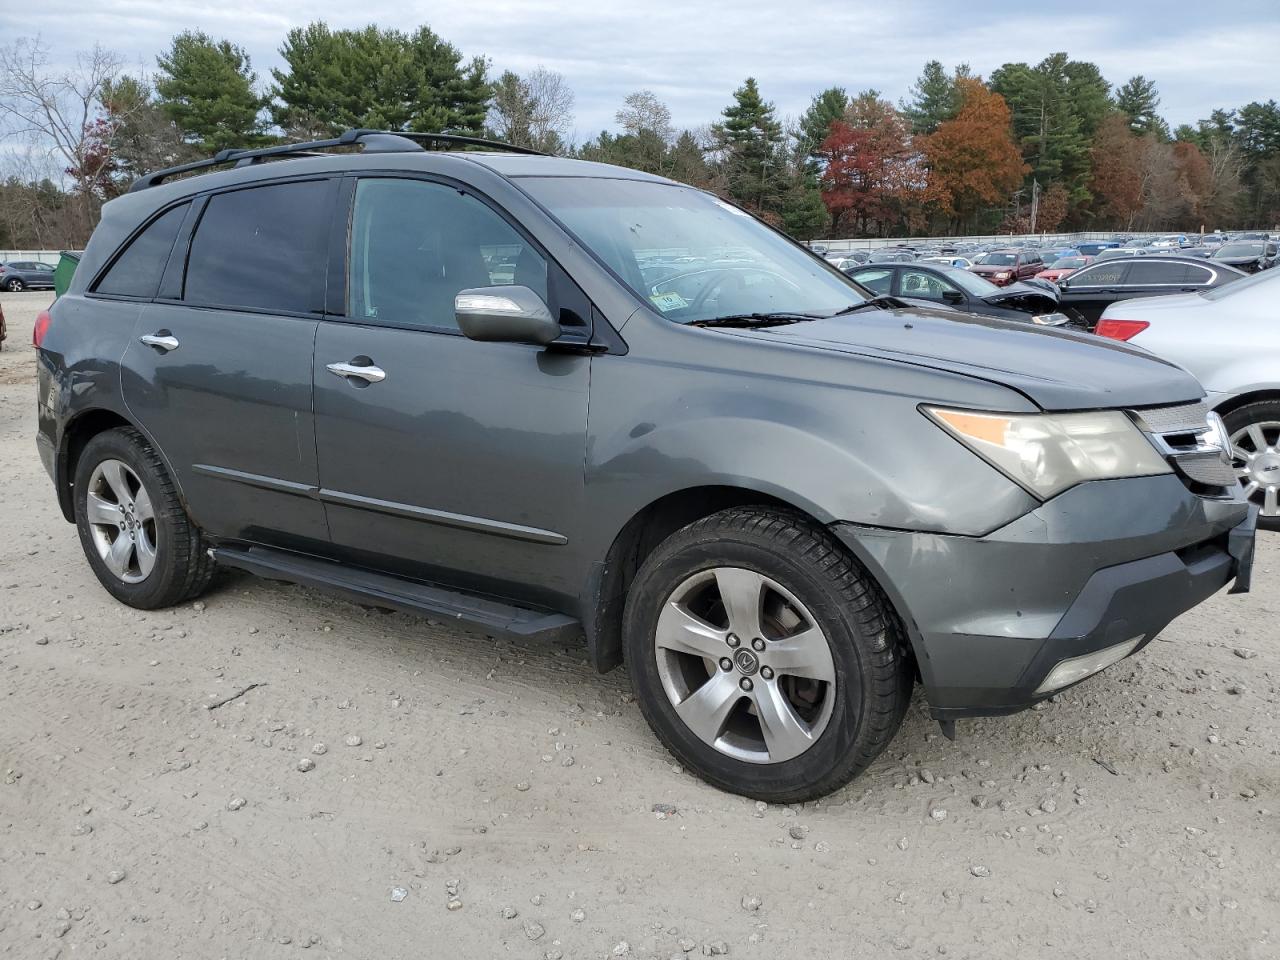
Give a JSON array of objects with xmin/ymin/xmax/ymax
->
[{"xmin": 1057, "ymin": 256, "xmax": 1244, "ymax": 329}]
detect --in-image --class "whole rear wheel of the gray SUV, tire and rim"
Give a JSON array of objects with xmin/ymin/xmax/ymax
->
[{"xmin": 74, "ymin": 428, "xmax": 214, "ymax": 609}]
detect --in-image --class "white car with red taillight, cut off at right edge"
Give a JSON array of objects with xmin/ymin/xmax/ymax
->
[{"xmin": 1094, "ymin": 270, "xmax": 1280, "ymax": 530}]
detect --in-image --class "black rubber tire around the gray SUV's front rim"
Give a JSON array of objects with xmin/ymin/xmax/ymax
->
[{"xmin": 623, "ymin": 507, "xmax": 914, "ymax": 803}]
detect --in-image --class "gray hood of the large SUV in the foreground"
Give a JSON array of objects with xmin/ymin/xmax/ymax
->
[{"xmin": 727, "ymin": 302, "xmax": 1204, "ymax": 410}]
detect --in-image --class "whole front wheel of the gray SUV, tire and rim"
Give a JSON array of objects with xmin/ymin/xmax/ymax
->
[{"xmin": 623, "ymin": 507, "xmax": 913, "ymax": 803}]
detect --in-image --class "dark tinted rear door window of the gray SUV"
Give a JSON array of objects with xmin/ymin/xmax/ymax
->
[{"xmin": 183, "ymin": 180, "xmax": 333, "ymax": 314}]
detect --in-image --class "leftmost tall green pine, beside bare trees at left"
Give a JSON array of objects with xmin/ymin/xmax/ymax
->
[{"xmin": 155, "ymin": 31, "xmax": 265, "ymax": 154}]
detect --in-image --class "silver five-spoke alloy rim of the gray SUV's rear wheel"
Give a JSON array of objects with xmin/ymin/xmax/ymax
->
[{"xmin": 84, "ymin": 460, "xmax": 156, "ymax": 584}]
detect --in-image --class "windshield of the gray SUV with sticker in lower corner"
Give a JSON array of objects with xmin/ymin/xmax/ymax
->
[{"xmin": 520, "ymin": 177, "xmax": 867, "ymax": 324}]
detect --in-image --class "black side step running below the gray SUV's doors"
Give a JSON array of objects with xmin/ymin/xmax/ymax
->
[{"xmin": 210, "ymin": 547, "xmax": 582, "ymax": 640}]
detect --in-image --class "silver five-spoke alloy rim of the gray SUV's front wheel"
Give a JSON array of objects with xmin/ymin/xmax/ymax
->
[{"xmin": 654, "ymin": 567, "xmax": 836, "ymax": 763}]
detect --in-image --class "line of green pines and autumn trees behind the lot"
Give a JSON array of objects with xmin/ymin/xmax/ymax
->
[{"xmin": 0, "ymin": 22, "xmax": 1280, "ymax": 247}]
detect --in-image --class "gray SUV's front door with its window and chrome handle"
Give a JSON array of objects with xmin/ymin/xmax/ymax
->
[{"xmin": 314, "ymin": 178, "xmax": 590, "ymax": 605}]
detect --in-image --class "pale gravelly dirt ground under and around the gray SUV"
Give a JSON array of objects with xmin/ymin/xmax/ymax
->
[{"xmin": 0, "ymin": 293, "xmax": 1280, "ymax": 960}]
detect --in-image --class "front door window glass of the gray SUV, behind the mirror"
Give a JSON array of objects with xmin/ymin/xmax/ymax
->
[{"xmin": 347, "ymin": 178, "xmax": 549, "ymax": 330}]
